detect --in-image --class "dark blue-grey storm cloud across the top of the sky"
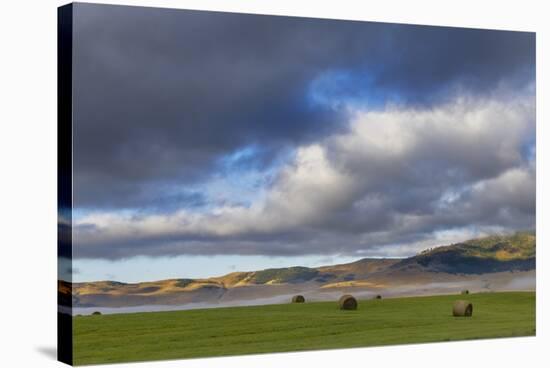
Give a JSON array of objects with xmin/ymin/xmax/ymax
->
[{"xmin": 74, "ymin": 4, "xmax": 535, "ymax": 212}]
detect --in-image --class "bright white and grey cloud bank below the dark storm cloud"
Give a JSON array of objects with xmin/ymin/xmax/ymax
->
[{"xmin": 74, "ymin": 88, "xmax": 535, "ymax": 258}]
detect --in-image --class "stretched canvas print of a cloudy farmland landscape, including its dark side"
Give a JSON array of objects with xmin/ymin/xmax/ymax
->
[{"xmin": 58, "ymin": 3, "xmax": 536, "ymax": 365}]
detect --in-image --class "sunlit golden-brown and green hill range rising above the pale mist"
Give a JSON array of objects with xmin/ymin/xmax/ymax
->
[{"xmin": 60, "ymin": 232, "xmax": 536, "ymax": 306}]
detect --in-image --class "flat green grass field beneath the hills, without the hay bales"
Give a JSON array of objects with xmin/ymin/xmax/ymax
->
[{"xmin": 74, "ymin": 292, "xmax": 535, "ymax": 365}]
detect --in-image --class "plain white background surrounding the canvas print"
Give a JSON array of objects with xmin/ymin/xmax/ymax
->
[{"xmin": 0, "ymin": 0, "xmax": 550, "ymax": 368}]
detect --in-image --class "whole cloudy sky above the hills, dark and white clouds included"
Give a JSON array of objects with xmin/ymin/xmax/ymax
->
[{"xmin": 62, "ymin": 4, "xmax": 536, "ymax": 282}]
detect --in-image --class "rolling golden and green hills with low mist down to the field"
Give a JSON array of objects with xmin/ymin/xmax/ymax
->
[{"xmin": 60, "ymin": 232, "xmax": 536, "ymax": 307}]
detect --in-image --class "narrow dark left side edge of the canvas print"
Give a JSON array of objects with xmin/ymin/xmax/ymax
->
[{"xmin": 57, "ymin": 4, "xmax": 73, "ymax": 365}]
